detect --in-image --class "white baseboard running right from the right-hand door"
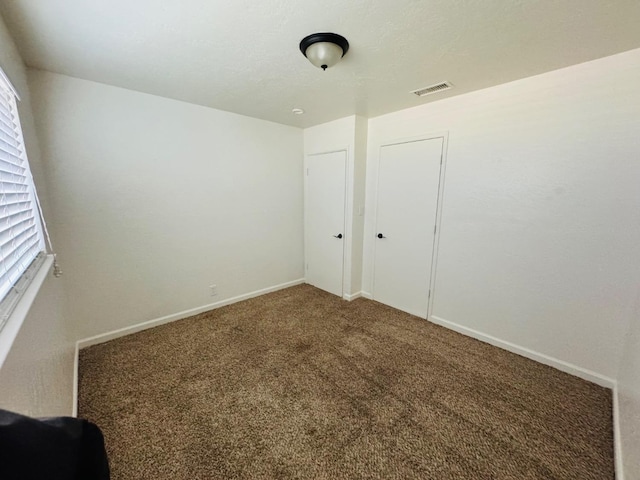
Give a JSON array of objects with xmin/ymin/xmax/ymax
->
[{"xmin": 428, "ymin": 315, "xmax": 616, "ymax": 388}]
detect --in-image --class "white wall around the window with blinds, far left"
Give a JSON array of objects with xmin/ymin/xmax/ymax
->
[{"xmin": 0, "ymin": 18, "xmax": 73, "ymax": 416}]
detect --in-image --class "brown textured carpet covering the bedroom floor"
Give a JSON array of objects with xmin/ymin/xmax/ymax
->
[{"xmin": 79, "ymin": 285, "xmax": 614, "ymax": 480}]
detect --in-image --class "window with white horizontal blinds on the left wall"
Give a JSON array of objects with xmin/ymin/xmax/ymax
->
[{"xmin": 0, "ymin": 70, "xmax": 45, "ymax": 329}]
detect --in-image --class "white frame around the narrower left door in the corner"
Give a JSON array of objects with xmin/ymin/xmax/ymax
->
[{"xmin": 302, "ymin": 147, "xmax": 352, "ymax": 298}]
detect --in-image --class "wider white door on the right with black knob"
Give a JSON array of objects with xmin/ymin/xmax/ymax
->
[{"xmin": 373, "ymin": 138, "xmax": 443, "ymax": 318}]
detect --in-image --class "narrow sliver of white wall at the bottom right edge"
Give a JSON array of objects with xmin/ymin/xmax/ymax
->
[{"xmin": 618, "ymin": 294, "xmax": 640, "ymax": 480}]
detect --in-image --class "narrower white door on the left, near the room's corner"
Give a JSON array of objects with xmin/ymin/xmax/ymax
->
[{"xmin": 305, "ymin": 151, "xmax": 347, "ymax": 296}]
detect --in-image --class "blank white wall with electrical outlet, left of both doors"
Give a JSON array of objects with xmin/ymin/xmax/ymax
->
[{"xmin": 29, "ymin": 71, "xmax": 303, "ymax": 338}]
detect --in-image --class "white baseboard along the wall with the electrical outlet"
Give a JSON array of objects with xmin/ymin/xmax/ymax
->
[{"xmin": 77, "ymin": 278, "xmax": 304, "ymax": 349}]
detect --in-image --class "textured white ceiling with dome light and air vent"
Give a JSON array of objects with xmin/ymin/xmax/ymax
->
[{"xmin": 0, "ymin": 0, "xmax": 640, "ymax": 127}]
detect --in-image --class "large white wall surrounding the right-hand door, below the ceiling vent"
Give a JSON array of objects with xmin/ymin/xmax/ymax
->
[{"xmin": 363, "ymin": 50, "xmax": 640, "ymax": 380}]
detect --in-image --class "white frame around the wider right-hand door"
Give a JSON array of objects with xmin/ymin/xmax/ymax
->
[{"xmin": 365, "ymin": 131, "xmax": 449, "ymax": 320}]
